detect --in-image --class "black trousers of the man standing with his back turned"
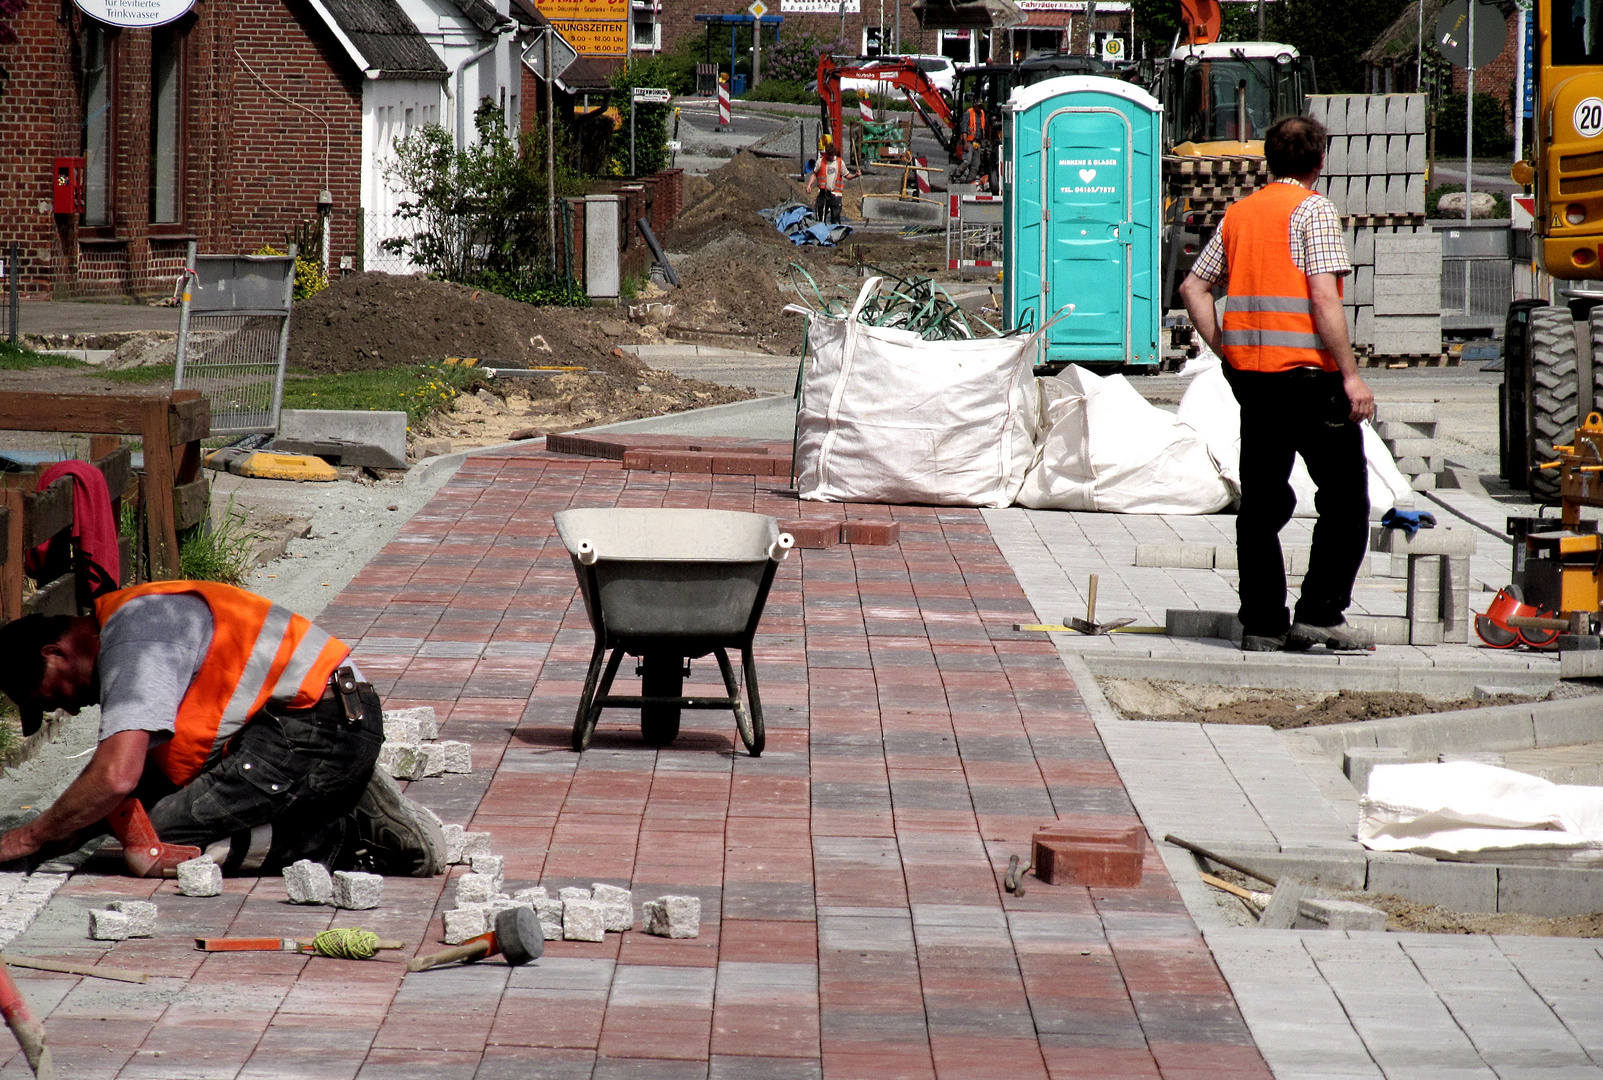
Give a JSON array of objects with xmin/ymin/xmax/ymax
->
[{"xmin": 1225, "ymin": 364, "xmax": 1369, "ymax": 638}]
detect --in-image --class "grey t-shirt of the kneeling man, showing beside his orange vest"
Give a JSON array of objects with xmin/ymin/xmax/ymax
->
[{"xmin": 99, "ymin": 593, "xmax": 212, "ymax": 744}]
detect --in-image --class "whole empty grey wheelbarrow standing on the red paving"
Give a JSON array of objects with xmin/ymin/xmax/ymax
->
[{"xmin": 556, "ymin": 508, "xmax": 792, "ymax": 758}]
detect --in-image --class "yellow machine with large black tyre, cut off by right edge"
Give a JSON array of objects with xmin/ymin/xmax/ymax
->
[{"xmin": 1499, "ymin": 0, "xmax": 1603, "ymax": 503}]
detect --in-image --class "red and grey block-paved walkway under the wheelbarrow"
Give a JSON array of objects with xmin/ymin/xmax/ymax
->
[{"xmin": 5, "ymin": 441, "xmax": 1268, "ymax": 1080}]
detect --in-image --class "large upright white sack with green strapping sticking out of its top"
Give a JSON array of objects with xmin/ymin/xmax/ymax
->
[{"xmin": 797, "ymin": 277, "xmax": 1040, "ymax": 508}]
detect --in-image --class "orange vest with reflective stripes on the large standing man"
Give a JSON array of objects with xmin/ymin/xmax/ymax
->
[{"xmin": 1218, "ymin": 183, "xmax": 1342, "ymax": 372}]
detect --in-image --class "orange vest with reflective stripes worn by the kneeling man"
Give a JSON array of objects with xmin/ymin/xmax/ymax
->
[{"xmin": 95, "ymin": 582, "xmax": 351, "ymax": 785}]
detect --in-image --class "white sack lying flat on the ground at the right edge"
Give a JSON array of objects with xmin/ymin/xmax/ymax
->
[{"xmin": 1358, "ymin": 761, "xmax": 1603, "ymax": 864}]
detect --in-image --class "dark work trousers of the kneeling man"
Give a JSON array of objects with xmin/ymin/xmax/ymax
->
[{"xmin": 135, "ymin": 683, "xmax": 385, "ymax": 873}]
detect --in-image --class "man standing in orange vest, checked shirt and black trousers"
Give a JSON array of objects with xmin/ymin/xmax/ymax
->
[{"xmin": 1180, "ymin": 117, "xmax": 1375, "ymax": 652}]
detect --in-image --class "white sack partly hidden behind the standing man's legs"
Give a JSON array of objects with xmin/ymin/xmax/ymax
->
[{"xmin": 1178, "ymin": 345, "xmax": 1414, "ymax": 519}]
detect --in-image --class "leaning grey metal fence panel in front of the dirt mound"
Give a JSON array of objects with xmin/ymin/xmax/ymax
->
[{"xmin": 173, "ymin": 244, "xmax": 295, "ymax": 434}]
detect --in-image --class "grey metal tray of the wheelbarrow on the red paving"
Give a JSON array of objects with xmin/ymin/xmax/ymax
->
[{"xmin": 556, "ymin": 508, "xmax": 779, "ymax": 640}]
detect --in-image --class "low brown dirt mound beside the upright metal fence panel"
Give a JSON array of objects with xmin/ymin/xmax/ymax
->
[{"xmin": 289, "ymin": 272, "xmax": 640, "ymax": 375}]
